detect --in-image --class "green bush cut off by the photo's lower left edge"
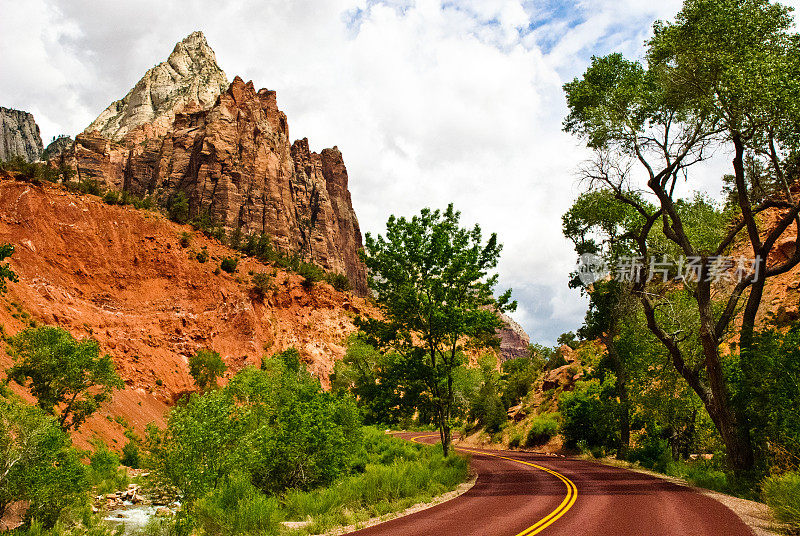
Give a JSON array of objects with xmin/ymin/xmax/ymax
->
[{"xmin": 0, "ymin": 395, "xmax": 88, "ymax": 528}]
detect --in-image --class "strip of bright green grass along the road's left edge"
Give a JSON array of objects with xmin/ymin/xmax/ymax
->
[{"xmin": 165, "ymin": 427, "xmax": 468, "ymax": 536}]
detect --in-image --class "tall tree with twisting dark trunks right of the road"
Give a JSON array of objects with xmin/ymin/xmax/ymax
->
[{"xmin": 564, "ymin": 0, "xmax": 800, "ymax": 473}]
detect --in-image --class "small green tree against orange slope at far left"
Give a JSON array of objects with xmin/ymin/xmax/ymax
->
[{"xmin": 8, "ymin": 326, "xmax": 125, "ymax": 430}]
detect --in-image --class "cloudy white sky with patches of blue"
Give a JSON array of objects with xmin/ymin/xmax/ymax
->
[{"xmin": 0, "ymin": 0, "xmax": 800, "ymax": 344}]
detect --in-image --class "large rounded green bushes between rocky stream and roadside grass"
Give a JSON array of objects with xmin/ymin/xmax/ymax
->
[{"xmin": 148, "ymin": 352, "xmax": 360, "ymax": 501}]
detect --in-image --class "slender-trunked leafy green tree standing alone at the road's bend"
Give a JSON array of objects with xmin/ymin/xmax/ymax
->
[{"xmin": 358, "ymin": 205, "xmax": 516, "ymax": 455}]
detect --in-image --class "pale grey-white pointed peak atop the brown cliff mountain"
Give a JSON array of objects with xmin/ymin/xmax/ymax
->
[{"xmin": 84, "ymin": 32, "xmax": 228, "ymax": 141}]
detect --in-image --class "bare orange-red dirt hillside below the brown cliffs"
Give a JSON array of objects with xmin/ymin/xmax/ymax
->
[{"xmin": 0, "ymin": 180, "xmax": 371, "ymax": 447}]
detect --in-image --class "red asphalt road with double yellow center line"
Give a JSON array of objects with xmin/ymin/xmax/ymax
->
[{"xmin": 351, "ymin": 433, "xmax": 753, "ymax": 536}]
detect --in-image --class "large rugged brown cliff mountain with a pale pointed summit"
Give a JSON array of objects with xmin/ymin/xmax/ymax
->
[{"xmin": 58, "ymin": 33, "xmax": 367, "ymax": 295}]
